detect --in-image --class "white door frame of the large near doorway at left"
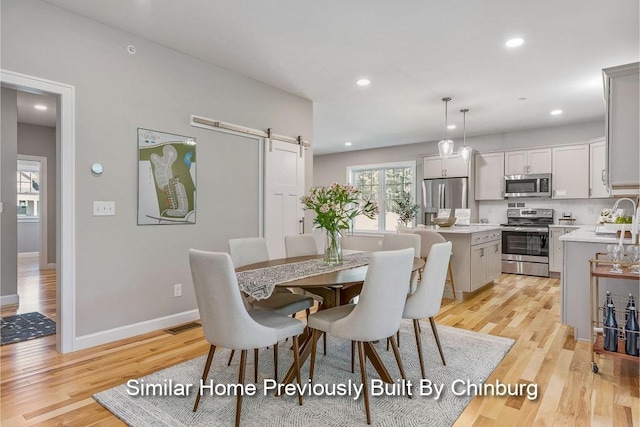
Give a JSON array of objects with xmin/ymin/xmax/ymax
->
[{"xmin": 0, "ymin": 70, "xmax": 76, "ymax": 353}]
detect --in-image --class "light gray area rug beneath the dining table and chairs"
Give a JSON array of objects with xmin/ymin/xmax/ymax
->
[{"xmin": 93, "ymin": 322, "xmax": 514, "ymax": 427}]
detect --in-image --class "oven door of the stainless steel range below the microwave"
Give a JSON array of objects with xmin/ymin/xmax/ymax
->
[{"xmin": 502, "ymin": 227, "xmax": 549, "ymax": 262}]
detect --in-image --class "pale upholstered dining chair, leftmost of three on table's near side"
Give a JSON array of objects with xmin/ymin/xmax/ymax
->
[{"xmin": 189, "ymin": 249, "xmax": 304, "ymax": 427}]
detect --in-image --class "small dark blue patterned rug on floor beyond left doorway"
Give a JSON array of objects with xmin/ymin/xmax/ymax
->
[{"xmin": 0, "ymin": 311, "xmax": 56, "ymax": 345}]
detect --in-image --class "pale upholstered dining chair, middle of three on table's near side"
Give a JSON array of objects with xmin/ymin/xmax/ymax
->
[{"xmin": 308, "ymin": 249, "xmax": 414, "ymax": 424}]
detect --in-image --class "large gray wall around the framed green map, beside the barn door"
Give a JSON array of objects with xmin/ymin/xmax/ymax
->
[{"xmin": 1, "ymin": 0, "xmax": 313, "ymax": 336}]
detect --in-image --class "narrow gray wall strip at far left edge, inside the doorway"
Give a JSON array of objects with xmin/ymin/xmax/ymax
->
[{"xmin": 0, "ymin": 88, "xmax": 18, "ymax": 297}]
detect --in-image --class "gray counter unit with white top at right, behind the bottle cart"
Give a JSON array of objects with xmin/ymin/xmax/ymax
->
[{"xmin": 559, "ymin": 226, "xmax": 640, "ymax": 341}]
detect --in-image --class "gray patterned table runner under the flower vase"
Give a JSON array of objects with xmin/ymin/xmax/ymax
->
[{"xmin": 237, "ymin": 252, "xmax": 371, "ymax": 300}]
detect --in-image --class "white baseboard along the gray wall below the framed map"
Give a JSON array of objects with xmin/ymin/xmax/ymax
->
[{"xmin": 73, "ymin": 310, "xmax": 200, "ymax": 351}]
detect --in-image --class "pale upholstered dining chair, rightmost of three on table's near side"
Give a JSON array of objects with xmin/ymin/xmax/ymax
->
[{"xmin": 402, "ymin": 242, "xmax": 452, "ymax": 378}]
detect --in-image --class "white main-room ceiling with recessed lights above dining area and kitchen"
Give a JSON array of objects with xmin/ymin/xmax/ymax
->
[{"xmin": 42, "ymin": 0, "xmax": 640, "ymax": 154}]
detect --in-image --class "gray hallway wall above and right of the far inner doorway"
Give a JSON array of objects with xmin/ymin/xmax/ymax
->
[{"xmin": 18, "ymin": 123, "xmax": 56, "ymax": 264}]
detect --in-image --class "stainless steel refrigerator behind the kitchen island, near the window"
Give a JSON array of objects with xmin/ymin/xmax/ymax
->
[{"xmin": 422, "ymin": 178, "xmax": 469, "ymax": 225}]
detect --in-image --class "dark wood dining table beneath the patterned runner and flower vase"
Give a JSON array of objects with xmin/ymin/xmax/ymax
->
[{"xmin": 236, "ymin": 254, "xmax": 425, "ymax": 384}]
